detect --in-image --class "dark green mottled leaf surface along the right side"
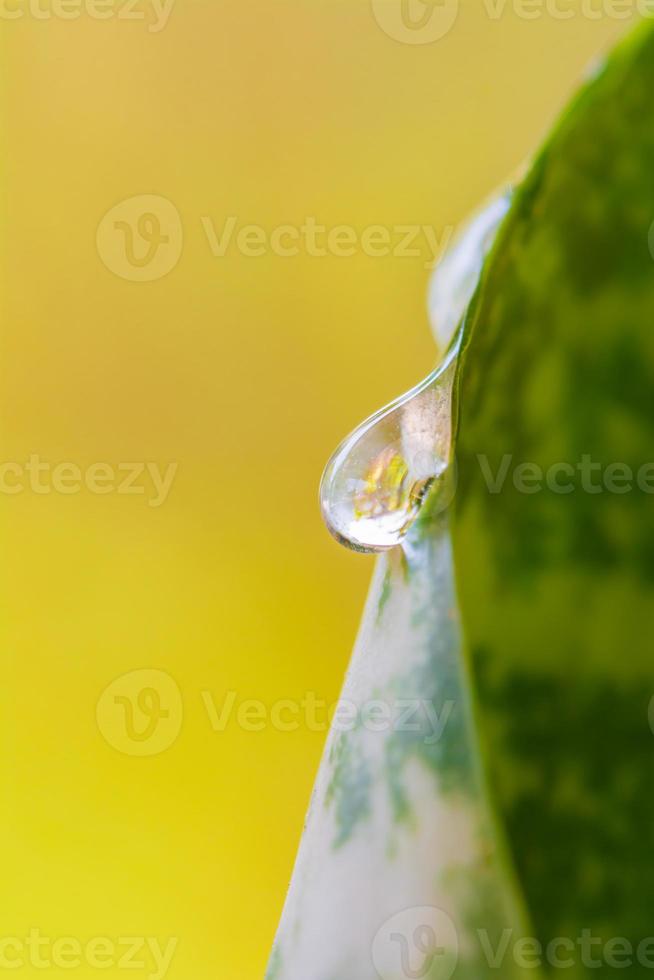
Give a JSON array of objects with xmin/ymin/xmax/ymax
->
[{"xmin": 453, "ymin": 21, "xmax": 654, "ymax": 977}]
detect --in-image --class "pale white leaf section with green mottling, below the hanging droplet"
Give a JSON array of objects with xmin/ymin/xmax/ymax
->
[{"xmin": 268, "ymin": 523, "xmax": 533, "ymax": 980}]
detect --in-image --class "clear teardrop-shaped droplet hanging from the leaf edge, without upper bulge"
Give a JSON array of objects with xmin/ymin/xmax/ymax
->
[{"xmin": 320, "ymin": 338, "xmax": 460, "ymax": 552}]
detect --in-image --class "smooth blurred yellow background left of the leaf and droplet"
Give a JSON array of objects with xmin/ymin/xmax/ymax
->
[{"xmin": 0, "ymin": 0, "xmax": 637, "ymax": 980}]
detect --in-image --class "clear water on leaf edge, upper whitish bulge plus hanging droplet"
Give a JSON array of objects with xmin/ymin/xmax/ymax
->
[{"xmin": 320, "ymin": 189, "xmax": 511, "ymax": 551}]
